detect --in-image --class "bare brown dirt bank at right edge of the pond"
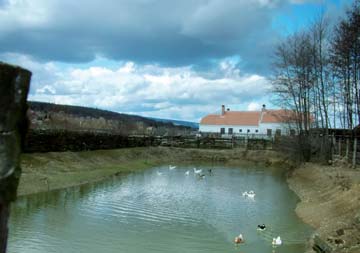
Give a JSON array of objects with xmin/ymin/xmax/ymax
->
[{"xmin": 288, "ymin": 163, "xmax": 360, "ymax": 253}]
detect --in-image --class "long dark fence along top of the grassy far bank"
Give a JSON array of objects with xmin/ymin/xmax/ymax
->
[{"xmin": 25, "ymin": 130, "xmax": 274, "ymax": 153}]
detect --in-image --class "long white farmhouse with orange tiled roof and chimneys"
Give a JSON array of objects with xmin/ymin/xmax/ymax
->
[{"xmin": 199, "ymin": 105, "xmax": 295, "ymax": 137}]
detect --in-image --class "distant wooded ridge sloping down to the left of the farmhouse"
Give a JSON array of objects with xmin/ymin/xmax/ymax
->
[{"xmin": 28, "ymin": 101, "xmax": 196, "ymax": 135}]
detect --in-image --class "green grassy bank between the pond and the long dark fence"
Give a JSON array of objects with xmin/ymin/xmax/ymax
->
[{"xmin": 18, "ymin": 147, "xmax": 290, "ymax": 195}]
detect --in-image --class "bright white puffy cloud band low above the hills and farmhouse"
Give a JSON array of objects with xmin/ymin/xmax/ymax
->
[{"xmin": 7, "ymin": 55, "xmax": 269, "ymax": 121}]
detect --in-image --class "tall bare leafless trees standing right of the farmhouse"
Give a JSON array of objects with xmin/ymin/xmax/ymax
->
[{"xmin": 271, "ymin": 0, "xmax": 360, "ymax": 160}]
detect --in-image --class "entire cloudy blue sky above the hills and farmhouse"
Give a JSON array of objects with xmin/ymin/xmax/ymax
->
[{"xmin": 0, "ymin": 0, "xmax": 352, "ymax": 122}]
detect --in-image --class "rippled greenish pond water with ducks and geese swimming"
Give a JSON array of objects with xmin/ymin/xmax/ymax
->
[{"xmin": 8, "ymin": 166, "xmax": 311, "ymax": 253}]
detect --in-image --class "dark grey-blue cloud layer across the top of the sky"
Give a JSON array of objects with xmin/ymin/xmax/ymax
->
[{"xmin": 0, "ymin": 0, "xmax": 298, "ymax": 72}]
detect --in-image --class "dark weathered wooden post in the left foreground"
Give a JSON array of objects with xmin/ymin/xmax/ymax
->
[{"xmin": 0, "ymin": 62, "xmax": 31, "ymax": 253}]
